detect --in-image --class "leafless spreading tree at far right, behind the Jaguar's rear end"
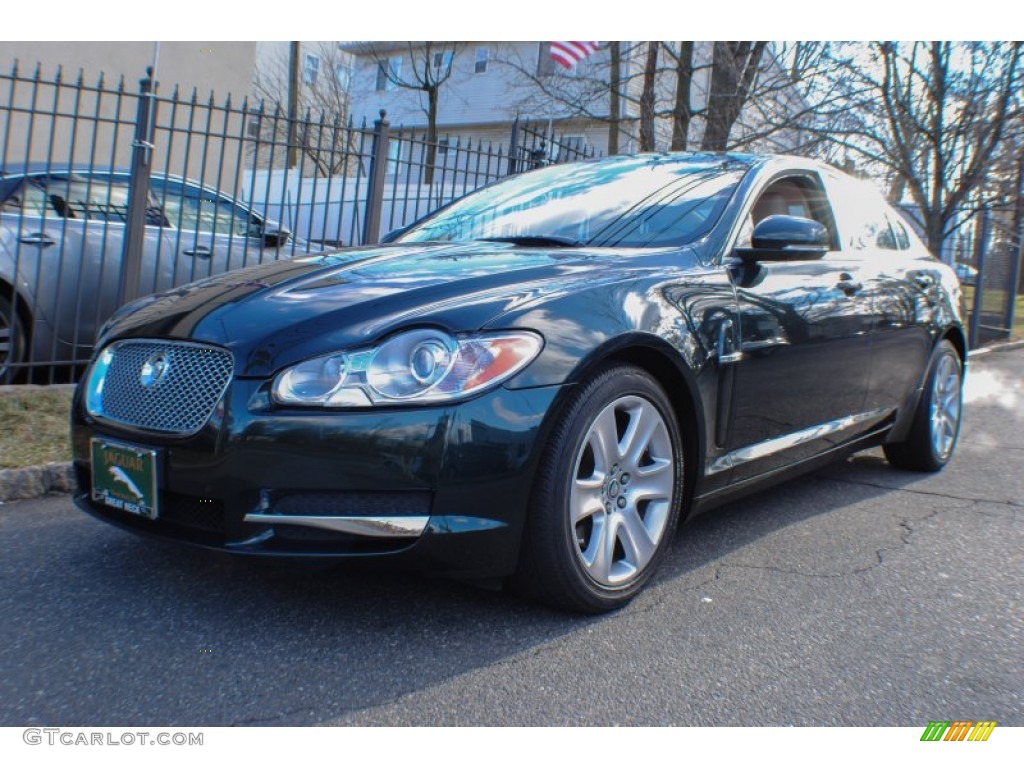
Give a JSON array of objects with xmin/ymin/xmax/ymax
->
[{"xmin": 808, "ymin": 42, "xmax": 1024, "ymax": 253}]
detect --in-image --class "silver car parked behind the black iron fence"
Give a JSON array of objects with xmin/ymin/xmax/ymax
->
[{"xmin": 0, "ymin": 164, "xmax": 309, "ymax": 382}]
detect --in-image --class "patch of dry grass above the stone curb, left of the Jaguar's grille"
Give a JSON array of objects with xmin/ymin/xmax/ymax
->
[{"xmin": 0, "ymin": 387, "xmax": 72, "ymax": 469}]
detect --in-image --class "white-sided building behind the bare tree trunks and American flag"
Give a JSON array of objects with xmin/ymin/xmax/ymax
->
[{"xmin": 342, "ymin": 42, "xmax": 802, "ymax": 160}]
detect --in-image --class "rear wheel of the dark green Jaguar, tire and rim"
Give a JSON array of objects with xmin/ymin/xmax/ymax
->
[{"xmin": 884, "ymin": 339, "xmax": 964, "ymax": 472}]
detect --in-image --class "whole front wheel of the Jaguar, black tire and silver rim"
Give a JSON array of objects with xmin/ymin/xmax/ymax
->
[{"xmin": 514, "ymin": 365, "xmax": 683, "ymax": 613}]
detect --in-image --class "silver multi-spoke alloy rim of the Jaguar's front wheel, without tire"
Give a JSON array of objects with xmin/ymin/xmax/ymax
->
[{"xmin": 568, "ymin": 395, "xmax": 676, "ymax": 588}]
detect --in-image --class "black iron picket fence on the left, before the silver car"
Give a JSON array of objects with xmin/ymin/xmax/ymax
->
[{"xmin": 0, "ymin": 63, "xmax": 594, "ymax": 383}]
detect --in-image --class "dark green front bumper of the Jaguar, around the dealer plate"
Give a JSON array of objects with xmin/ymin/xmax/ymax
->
[{"xmin": 72, "ymin": 379, "xmax": 561, "ymax": 579}]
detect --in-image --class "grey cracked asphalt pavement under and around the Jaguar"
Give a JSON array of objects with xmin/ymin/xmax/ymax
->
[{"xmin": 0, "ymin": 349, "xmax": 1024, "ymax": 727}]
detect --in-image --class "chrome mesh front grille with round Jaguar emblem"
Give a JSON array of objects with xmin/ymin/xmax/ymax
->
[{"xmin": 86, "ymin": 339, "xmax": 233, "ymax": 435}]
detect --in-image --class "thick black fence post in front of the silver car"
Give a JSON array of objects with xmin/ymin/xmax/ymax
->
[{"xmin": 118, "ymin": 67, "xmax": 156, "ymax": 306}]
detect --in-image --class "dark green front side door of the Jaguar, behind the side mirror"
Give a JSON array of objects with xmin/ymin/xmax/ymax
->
[{"xmin": 721, "ymin": 173, "xmax": 872, "ymax": 482}]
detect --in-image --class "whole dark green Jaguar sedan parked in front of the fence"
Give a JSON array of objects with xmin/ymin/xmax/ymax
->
[{"xmin": 73, "ymin": 155, "xmax": 966, "ymax": 612}]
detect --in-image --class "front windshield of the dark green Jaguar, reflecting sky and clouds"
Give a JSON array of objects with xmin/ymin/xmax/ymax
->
[{"xmin": 395, "ymin": 156, "xmax": 746, "ymax": 248}]
